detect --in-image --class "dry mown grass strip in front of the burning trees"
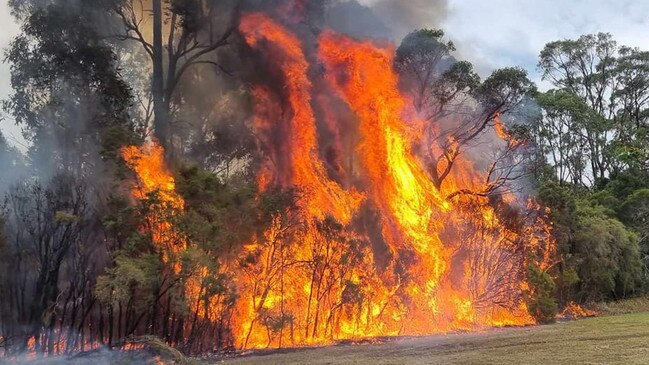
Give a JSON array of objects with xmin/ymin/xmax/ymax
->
[{"xmin": 218, "ymin": 313, "xmax": 649, "ymax": 365}]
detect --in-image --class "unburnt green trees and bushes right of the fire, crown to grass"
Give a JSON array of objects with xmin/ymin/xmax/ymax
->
[{"xmin": 529, "ymin": 33, "xmax": 649, "ymax": 313}]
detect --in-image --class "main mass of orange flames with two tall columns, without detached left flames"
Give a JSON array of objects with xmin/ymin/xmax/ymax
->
[{"xmin": 228, "ymin": 13, "xmax": 548, "ymax": 348}]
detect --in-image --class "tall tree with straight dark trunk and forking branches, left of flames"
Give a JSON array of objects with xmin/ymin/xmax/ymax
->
[{"xmin": 113, "ymin": 0, "xmax": 236, "ymax": 147}]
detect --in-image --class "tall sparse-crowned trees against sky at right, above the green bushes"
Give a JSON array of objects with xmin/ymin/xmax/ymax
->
[{"xmin": 539, "ymin": 33, "xmax": 649, "ymax": 182}]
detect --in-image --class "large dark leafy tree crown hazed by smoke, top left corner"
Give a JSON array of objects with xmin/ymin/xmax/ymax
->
[{"xmin": 3, "ymin": 1, "xmax": 132, "ymax": 175}]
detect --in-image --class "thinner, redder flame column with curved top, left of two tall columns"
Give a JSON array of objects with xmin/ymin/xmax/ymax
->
[{"xmin": 240, "ymin": 14, "xmax": 362, "ymax": 223}]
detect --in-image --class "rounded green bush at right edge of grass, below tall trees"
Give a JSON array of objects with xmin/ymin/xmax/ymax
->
[{"xmin": 538, "ymin": 177, "xmax": 645, "ymax": 303}]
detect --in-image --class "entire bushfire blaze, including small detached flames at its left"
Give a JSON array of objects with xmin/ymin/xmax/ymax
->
[{"xmin": 123, "ymin": 13, "xmax": 553, "ymax": 349}]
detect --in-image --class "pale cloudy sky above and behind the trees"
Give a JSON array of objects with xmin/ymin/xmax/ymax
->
[{"xmin": 0, "ymin": 0, "xmax": 649, "ymax": 143}]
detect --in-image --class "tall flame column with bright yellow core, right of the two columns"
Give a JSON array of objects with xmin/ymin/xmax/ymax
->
[{"xmin": 320, "ymin": 29, "xmax": 450, "ymax": 291}]
